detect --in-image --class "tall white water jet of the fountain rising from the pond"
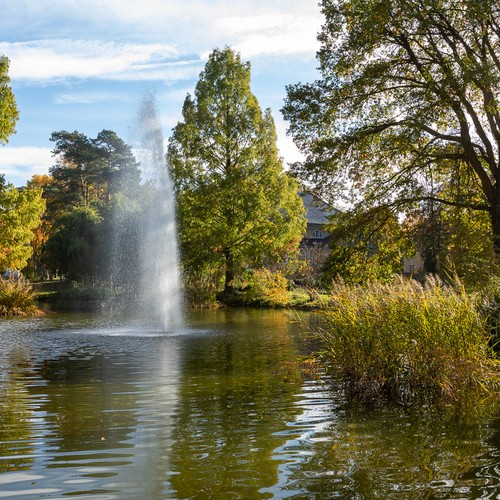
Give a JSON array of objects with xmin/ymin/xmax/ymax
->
[{"xmin": 114, "ymin": 93, "xmax": 182, "ymax": 330}]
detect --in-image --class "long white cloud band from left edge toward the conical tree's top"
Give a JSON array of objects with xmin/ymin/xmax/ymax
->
[{"xmin": 0, "ymin": 39, "xmax": 205, "ymax": 81}]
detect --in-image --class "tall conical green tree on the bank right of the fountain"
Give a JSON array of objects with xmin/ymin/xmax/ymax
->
[{"xmin": 167, "ymin": 48, "xmax": 305, "ymax": 292}]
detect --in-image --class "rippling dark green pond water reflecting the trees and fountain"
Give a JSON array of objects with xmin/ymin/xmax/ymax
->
[{"xmin": 0, "ymin": 311, "xmax": 500, "ymax": 499}]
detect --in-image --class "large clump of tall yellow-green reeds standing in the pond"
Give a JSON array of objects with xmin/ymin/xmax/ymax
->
[{"xmin": 321, "ymin": 278, "xmax": 498, "ymax": 402}]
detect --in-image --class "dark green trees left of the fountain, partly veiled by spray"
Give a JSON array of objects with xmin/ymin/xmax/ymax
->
[{"xmin": 36, "ymin": 130, "xmax": 146, "ymax": 293}]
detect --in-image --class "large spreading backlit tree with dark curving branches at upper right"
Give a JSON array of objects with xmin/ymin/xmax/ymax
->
[{"xmin": 283, "ymin": 0, "xmax": 500, "ymax": 256}]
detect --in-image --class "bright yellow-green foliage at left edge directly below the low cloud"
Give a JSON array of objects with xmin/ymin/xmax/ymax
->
[{"xmin": 0, "ymin": 177, "xmax": 45, "ymax": 270}]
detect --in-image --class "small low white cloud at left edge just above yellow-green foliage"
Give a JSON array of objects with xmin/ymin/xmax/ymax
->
[{"xmin": 0, "ymin": 145, "xmax": 54, "ymax": 186}]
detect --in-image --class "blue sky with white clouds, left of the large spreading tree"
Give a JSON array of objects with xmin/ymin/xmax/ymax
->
[{"xmin": 0, "ymin": 0, "xmax": 323, "ymax": 186}]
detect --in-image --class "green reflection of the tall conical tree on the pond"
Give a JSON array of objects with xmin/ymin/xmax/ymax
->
[{"xmin": 171, "ymin": 311, "xmax": 300, "ymax": 498}]
